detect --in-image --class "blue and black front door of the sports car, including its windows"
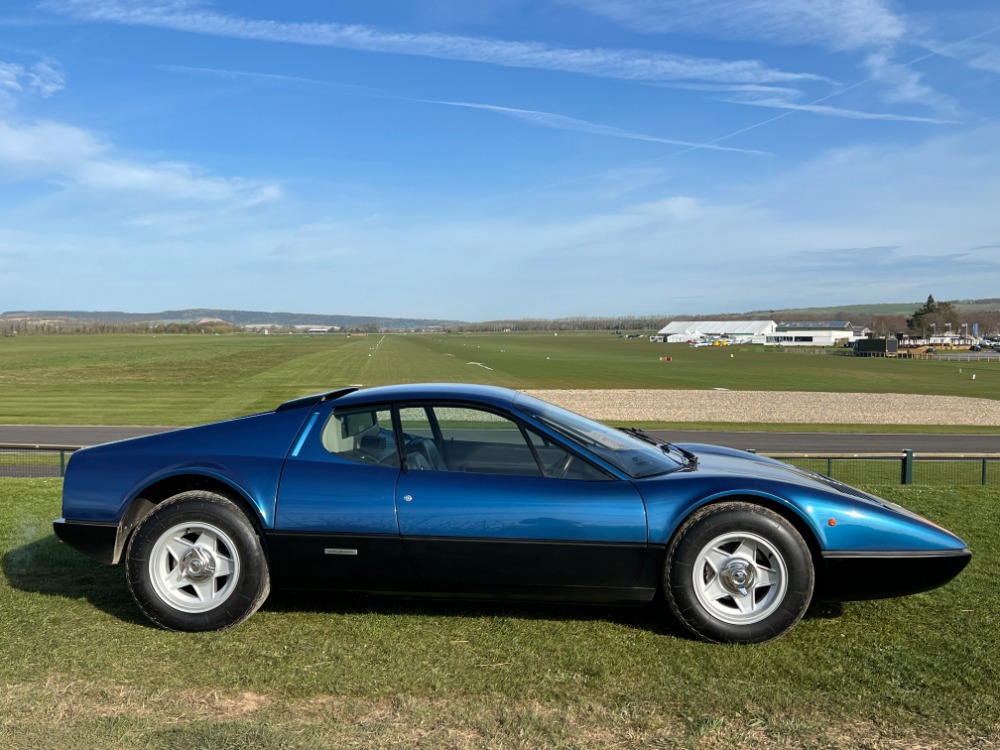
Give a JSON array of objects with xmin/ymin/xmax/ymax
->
[{"xmin": 396, "ymin": 404, "xmax": 646, "ymax": 593}]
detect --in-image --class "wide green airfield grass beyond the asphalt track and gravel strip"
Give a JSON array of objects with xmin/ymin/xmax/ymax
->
[{"xmin": 0, "ymin": 333, "xmax": 1000, "ymax": 431}]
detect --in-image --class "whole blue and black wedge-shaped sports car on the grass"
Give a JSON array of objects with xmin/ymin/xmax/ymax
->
[{"xmin": 54, "ymin": 384, "xmax": 971, "ymax": 643}]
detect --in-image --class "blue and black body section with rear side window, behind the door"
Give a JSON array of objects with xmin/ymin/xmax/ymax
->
[{"xmin": 267, "ymin": 406, "xmax": 415, "ymax": 590}]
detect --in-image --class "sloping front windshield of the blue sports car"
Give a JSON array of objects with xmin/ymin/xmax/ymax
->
[{"xmin": 514, "ymin": 393, "xmax": 684, "ymax": 479}]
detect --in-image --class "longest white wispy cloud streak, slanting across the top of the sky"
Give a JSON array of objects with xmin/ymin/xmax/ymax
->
[{"xmin": 43, "ymin": 0, "xmax": 825, "ymax": 83}]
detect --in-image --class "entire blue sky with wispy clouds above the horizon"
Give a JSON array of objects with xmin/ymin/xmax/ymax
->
[{"xmin": 0, "ymin": 0, "xmax": 1000, "ymax": 320}]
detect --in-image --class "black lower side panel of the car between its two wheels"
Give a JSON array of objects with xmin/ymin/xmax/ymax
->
[{"xmin": 266, "ymin": 532, "xmax": 664, "ymax": 604}]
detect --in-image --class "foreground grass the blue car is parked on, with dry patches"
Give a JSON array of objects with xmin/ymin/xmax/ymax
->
[{"xmin": 0, "ymin": 479, "xmax": 1000, "ymax": 750}]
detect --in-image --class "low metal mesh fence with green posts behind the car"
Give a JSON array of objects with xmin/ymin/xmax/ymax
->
[{"xmin": 0, "ymin": 444, "xmax": 1000, "ymax": 486}]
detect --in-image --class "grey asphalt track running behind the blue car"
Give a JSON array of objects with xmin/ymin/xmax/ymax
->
[{"xmin": 0, "ymin": 425, "xmax": 1000, "ymax": 454}]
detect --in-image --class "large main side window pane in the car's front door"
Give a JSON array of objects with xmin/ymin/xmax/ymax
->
[{"xmin": 399, "ymin": 406, "xmax": 542, "ymax": 477}]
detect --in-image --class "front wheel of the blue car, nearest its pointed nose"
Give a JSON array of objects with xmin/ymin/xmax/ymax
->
[{"xmin": 663, "ymin": 502, "xmax": 815, "ymax": 643}]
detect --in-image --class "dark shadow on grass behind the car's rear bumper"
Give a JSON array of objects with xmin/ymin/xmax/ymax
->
[{"xmin": 0, "ymin": 536, "xmax": 152, "ymax": 627}]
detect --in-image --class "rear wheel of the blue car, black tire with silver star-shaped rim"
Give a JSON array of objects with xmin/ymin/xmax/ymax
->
[{"xmin": 125, "ymin": 490, "xmax": 271, "ymax": 632}]
